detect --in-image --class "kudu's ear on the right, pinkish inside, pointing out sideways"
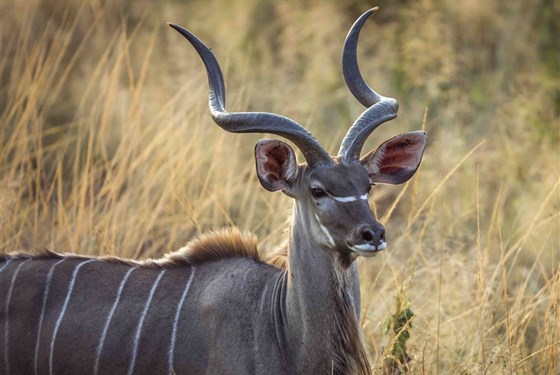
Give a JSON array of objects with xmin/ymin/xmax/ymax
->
[{"xmin": 360, "ymin": 131, "xmax": 427, "ymax": 185}]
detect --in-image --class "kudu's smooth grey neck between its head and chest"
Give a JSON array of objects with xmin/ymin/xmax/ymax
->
[{"xmin": 278, "ymin": 201, "xmax": 366, "ymax": 373}]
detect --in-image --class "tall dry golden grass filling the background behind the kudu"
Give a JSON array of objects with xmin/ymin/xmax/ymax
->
[{"xmin": 0, "ymin": 0, "xmax": 560, "ymax": 374}]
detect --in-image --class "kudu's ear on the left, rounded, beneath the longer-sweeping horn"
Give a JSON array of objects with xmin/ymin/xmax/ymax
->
[{"xmin": 255, "ymin": 139, "xmax": 298, "ymax": 191}]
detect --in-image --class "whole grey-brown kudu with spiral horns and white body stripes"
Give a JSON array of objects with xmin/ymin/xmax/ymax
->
[{"xmin": 0, "ymin": 10, "xmax": 426, "ymax": 375}]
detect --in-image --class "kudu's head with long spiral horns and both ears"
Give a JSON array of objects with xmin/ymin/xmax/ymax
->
[{"xmin": 170, "ymin": 8, "xmax": 426, "ymax": 265}]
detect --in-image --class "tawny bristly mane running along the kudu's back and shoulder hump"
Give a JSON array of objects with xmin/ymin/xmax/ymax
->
[{"xmin": 0, "ymin": 228, "xmax": 280, "ymax": 269}]
